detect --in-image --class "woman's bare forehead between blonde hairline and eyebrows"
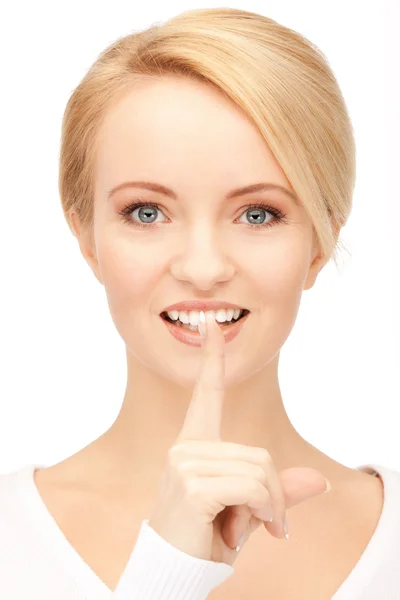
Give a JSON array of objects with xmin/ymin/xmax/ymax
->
[{"xmin": 96, "ymin": 77, "xmax": 291, "ymax": 197}]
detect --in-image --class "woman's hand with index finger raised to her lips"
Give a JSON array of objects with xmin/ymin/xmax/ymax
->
[{"xmin": 149, "ymin": 313, "xmax": 326, "ymax": 565}]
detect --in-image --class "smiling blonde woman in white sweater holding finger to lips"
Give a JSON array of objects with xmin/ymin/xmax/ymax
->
[{"xmin": 0, "ymin": 8, "xmax": 400, "ymax": 600}]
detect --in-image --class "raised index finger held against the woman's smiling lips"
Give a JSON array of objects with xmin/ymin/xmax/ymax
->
[{"xmin": 178, "ymin": 313, "xmax": 225, "ymax": 441}]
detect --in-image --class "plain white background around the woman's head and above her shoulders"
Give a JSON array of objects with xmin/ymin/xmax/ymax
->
[{"xmin": 0, "ymin": 0, "xmax": 400, "ymax": 473}]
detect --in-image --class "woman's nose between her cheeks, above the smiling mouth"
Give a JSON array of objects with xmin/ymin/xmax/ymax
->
[{"xmin": 170, "ymin": 229, "xmax": 235, "ymax": 290}]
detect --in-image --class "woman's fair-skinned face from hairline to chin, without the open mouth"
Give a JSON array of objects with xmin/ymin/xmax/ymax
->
[{"xmin": 76, "ymin": 77, "xmax": 321, "ymax": 387}]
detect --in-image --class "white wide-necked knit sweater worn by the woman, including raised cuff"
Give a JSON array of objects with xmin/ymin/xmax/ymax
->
[{"xmin": 0, "ymin": 465, "xmax": 400, "ymax": 600}]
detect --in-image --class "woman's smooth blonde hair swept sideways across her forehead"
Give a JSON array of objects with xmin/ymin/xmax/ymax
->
[{"xmin": 59, "ymin": 8, "xmax": 356, "ymax": 266}]
